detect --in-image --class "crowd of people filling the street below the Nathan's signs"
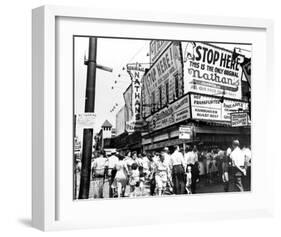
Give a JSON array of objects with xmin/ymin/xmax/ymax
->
[{"xmin": 73, "ymin": 140, "xmax": 251, "ymax": 198}]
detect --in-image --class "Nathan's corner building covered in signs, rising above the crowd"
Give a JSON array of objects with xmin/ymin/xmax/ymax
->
[{"xmin": 141, "ymin": 41, "xmax": 251, "ymax": 151}]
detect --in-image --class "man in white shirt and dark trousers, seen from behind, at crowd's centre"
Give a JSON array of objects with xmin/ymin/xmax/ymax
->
[{"xmin": 171, "ymin": 146, "xmax": 185, "ymax": 194}]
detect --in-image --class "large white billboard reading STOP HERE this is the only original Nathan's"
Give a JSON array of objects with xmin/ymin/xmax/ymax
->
[{"xmin": 183, "ymin": 42, "xmax": 242, "ymax": 99}]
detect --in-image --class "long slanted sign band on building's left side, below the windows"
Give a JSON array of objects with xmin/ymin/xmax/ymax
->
[{"xmin": 146, "ymin": 95, "xmax": 190, "ymax": 131}]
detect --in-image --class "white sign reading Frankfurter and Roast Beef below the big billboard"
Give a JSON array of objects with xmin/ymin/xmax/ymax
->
[{"xmin": 190, "ymin": 94, "xmax": 248, "ymax": 122}]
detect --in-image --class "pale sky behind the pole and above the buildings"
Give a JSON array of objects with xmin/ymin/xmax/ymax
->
[{"xmin": 74, "ymin": 37, "xmax": 251, "ymax": 141}]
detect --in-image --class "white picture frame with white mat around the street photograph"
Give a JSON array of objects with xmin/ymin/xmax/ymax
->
[{"xmin": 32, "ymin": 6, "xmax": 274, "ymax": 231}]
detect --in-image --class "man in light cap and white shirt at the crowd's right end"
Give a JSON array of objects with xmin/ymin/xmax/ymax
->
[{"xmin": 230, "ymin": 140, "xmax": 246, "ymax": 192}]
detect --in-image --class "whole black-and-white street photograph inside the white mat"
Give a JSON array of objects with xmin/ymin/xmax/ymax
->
[{"xmin": 73, "ymin": 35, "xmax": 252, "ymax": 200}]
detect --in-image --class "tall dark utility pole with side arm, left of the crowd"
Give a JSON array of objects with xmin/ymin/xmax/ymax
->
[{"xmin": 78, "ymin": 37, "xmax": 112, "ymax": 199}]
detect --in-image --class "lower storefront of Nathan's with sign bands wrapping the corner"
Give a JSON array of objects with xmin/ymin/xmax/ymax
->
[{"xmin": 142, "ymin": 93, "xmax": 250, "ymax": 151}]
